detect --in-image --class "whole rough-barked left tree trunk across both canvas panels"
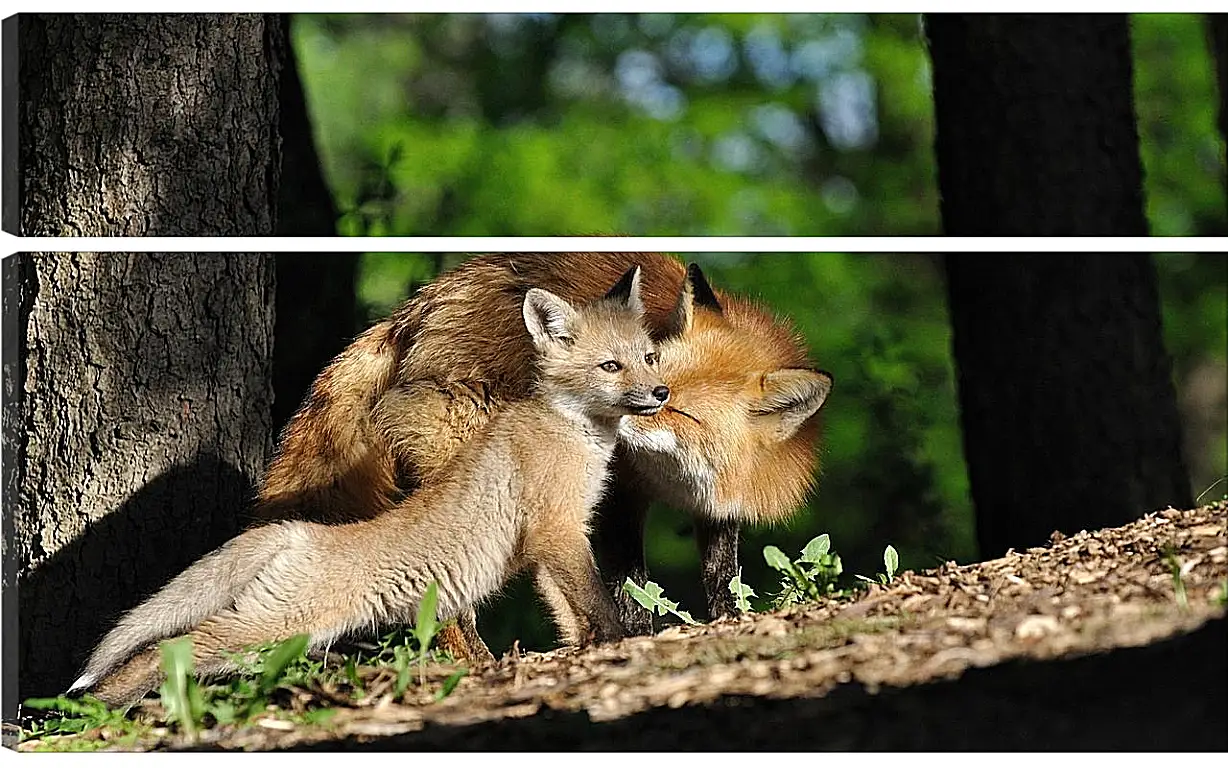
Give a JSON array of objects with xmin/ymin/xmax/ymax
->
[{"xmin": 4, "ymin": 15, "xmax": 284, "ymax": 714}]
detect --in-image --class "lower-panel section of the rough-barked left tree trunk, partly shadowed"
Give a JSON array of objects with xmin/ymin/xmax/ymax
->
[{"xmin": 4, "ymin": 254, "xmax": 274, "ymax": 714}]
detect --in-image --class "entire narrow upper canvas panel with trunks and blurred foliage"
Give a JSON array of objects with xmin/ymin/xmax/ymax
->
[{"xmin": 4, "ymin": 14, "xmax": 1228, "ymax": 236}]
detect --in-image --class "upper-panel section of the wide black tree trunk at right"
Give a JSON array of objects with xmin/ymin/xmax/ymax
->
[{"xmin": 925, "ymin": 14, "xmax": 1147, "ymax": 236}]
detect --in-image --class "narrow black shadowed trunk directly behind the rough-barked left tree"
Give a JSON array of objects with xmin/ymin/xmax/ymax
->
[{"xmin": 273, "ymin": 16, "xmax": 357, "ymax": 431}]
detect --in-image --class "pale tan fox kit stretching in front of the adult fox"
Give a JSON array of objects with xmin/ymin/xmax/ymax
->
[{"xmin": 74, "ymin": 268, "xmax": 669, "ymax": 704}]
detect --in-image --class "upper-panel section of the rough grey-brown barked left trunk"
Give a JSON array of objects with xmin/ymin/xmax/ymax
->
[{"xmin": 17, "ymin": 14, "xmax": 284, "ymax": 236}]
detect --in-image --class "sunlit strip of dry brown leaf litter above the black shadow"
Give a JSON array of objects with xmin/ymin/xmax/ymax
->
[{"xmin": 21, "ymin": 503, "xmax": 1228, "ymax": 748}]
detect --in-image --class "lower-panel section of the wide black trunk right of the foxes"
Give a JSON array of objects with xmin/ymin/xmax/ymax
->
[{"xmin": 947, "ymin": 254, "xmax": 1192, "ymax": 558}]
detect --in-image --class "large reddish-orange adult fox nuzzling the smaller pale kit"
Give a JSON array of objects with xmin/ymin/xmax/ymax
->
[{"xmin": 257, "ymin": 253, "xmax": 831, "ymax": 655}]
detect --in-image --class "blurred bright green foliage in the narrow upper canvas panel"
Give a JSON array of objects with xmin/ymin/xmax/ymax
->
[{"xmin": 293, "ymin": 14, "xmax": 1228, "ymax": 236}]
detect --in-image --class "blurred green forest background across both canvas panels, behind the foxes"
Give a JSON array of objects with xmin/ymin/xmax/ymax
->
[{"xmin": 278, "ymin": 14, "xmax": 1228, "ymax": 649}]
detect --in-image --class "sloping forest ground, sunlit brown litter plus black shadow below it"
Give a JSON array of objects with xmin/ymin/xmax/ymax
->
[{"xmin": 18, "ymin": 503, "xmax": 1228, "ymax": 751}]
